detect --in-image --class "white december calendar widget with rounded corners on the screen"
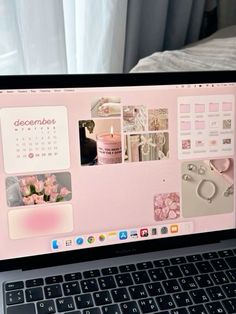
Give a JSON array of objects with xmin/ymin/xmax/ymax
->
[{"xmin": 0, "ymin": 106, "xmax": 70, "ymax": 173}]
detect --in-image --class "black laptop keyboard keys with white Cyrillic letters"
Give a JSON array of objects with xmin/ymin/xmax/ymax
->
[{"xmin": 4, "ymin": 249, "xmax": 236, "ymax": 314}]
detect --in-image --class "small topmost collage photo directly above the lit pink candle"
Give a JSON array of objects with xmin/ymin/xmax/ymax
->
[{"xmin": 91, "ymin": 96, "xmax": 121, "ymax": 118}]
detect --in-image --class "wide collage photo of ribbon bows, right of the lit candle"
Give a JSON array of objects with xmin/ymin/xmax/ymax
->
[{"xmin": 124, "ymin": 132, "xmax": 169, "ymax": 162}]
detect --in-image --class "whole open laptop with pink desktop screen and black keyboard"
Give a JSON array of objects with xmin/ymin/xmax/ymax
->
[{"xmin": 0, "ymin": 71, "xmax": 236, "ymax": 314}]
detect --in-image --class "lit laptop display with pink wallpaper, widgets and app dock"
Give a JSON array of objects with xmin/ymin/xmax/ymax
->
[{"xmin": 0, "ymin": 75, "xmax": 236, "ymax": 260}]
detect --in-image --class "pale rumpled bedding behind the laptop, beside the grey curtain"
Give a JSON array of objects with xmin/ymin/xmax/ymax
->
[{"xmin": 131, "ymin": 27, "xmax": 236, "ymax": 72}]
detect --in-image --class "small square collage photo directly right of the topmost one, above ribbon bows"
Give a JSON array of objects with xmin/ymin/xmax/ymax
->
[{"xmin": 123, "ymin": 106, "xmax": 147, "ymax": 132}]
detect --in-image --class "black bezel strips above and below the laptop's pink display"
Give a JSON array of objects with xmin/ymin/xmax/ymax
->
[{"xmin": 0, "ymin": 71, "xmax": 236, "ymax": 272}]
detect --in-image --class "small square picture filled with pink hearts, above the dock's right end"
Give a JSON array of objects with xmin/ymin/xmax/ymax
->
[{"xmin": 154, "ymin": 192, "xmax": 180, "ymax": 221}]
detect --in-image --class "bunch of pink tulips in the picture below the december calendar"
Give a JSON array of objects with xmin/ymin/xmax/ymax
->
[{"xmin": 18, "ymin": 173, "xmax": 71, "ymax": 206}]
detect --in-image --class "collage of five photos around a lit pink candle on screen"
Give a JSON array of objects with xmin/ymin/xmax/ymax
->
[{"xmin": 78, "ymin": 97, "xmax": 169, "ymax": 166}]
